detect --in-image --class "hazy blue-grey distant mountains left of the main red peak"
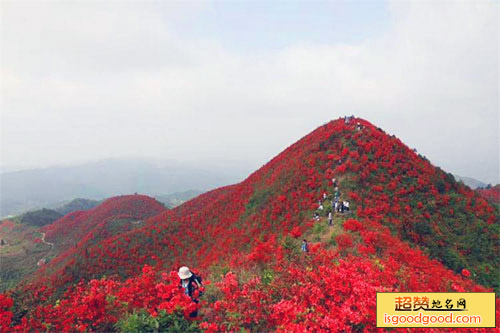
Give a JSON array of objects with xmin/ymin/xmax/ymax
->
[{"xmin": 0, "ymin": 159, "xmax": 241, "ymax": 217}]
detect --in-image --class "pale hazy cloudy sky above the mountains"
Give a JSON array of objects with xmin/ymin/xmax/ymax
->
[{"xmin": 1, "ymin": 0, "xmax": 500, "ymax": 183}]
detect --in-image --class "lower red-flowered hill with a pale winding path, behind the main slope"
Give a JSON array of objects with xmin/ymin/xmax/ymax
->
[{"xmin": 0, "ymin": 195, "xmax": 165, "ymax": 290}]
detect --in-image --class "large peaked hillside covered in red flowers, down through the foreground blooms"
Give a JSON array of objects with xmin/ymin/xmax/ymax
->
[{"xmin": 1, "ymin": 119, "xmax": 499, "ymax": 331}]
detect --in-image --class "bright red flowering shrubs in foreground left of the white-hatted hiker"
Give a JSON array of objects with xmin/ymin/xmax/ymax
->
[{"xmin": 4, "ymin": 266, "xmax": 199, "ymax": 332}]
